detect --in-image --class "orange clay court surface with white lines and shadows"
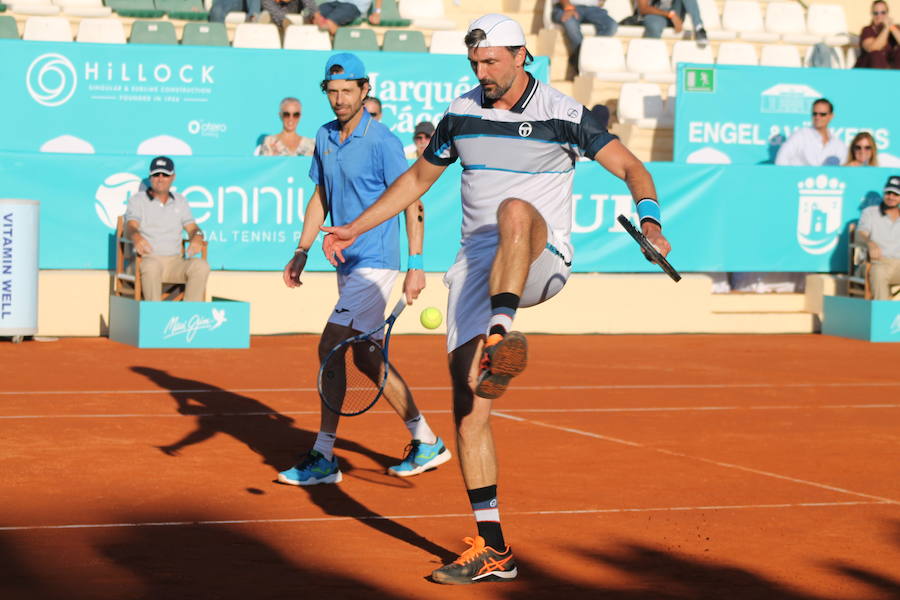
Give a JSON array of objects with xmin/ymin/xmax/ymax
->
[{"xmin": 0, "ymin": 335, "xmax": 900, "ymax": 600}]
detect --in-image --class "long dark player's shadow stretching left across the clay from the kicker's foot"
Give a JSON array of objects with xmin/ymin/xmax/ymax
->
[{"xmin": 131, "ymin": 366, "xmax": 455, "ymax": 562}]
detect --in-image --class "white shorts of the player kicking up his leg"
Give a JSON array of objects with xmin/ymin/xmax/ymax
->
[{"xmin": 444, "ymin": 227, "xmax": 572, "ymax": 352}]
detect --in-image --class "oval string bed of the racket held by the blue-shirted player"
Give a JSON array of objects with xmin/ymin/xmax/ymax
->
[{"xmin": 321, "ymin": 340, "xmax": 385, "ymax": 415}]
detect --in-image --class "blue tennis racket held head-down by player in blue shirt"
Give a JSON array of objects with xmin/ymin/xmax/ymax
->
[{"xmin": 318, "ymin": 298, "xmax": 406, "ymax": 417}]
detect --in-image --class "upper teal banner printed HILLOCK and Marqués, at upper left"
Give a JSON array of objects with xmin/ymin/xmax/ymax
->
[{"xmin": 0, "ymin": 40, "xmax": 549, "ymax": 156}]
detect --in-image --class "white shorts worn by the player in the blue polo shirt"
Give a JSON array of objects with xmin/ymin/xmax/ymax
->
[{"xmin": 328, "ymin": 267, "xmax": 398, "ymax": 339}]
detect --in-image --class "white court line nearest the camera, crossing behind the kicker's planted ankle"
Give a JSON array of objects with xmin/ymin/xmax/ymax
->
[{"xmin": 0, "ymin": 501, "xmax": 891, "ymax": 531}]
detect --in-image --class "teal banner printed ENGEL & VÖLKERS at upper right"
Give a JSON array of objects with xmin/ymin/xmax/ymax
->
[{"xmin": 675, "ymin": 64, "xmax": 900, "ymax": 166}]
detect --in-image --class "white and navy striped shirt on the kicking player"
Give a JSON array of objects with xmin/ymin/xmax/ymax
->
[{"xmin": 424, "ymin": 74, "xmax": 617, "ymax": 246}]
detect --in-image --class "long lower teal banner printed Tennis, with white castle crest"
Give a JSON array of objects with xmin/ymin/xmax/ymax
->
[{"xmin": 0, "ymin": 153, "xmax": 893, "ymax": 272}]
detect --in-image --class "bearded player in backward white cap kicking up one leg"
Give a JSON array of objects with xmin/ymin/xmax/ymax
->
[{"xmin": 323, "ymin": 14, "xmax": 670, "ymax": 584}]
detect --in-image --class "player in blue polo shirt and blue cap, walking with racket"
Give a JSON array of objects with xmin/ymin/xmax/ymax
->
[{"xmin": 278, "ymin": 53, "xmax": 450, "ymax": 485}]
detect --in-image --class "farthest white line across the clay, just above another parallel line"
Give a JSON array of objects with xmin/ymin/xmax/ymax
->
[{"xmin": 0, "ymin": 381, "xmax": 900, "ymax": 396}]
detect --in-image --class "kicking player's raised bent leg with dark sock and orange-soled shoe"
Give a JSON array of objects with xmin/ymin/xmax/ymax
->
[{"xmin": 475, "ymin": 198, "xmax": 547, "ymax": 398}]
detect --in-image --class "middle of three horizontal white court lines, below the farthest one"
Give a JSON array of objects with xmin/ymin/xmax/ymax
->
[{"xmin": 0, "ymin": 404, "xmax": 900, "ymax": 420}]
